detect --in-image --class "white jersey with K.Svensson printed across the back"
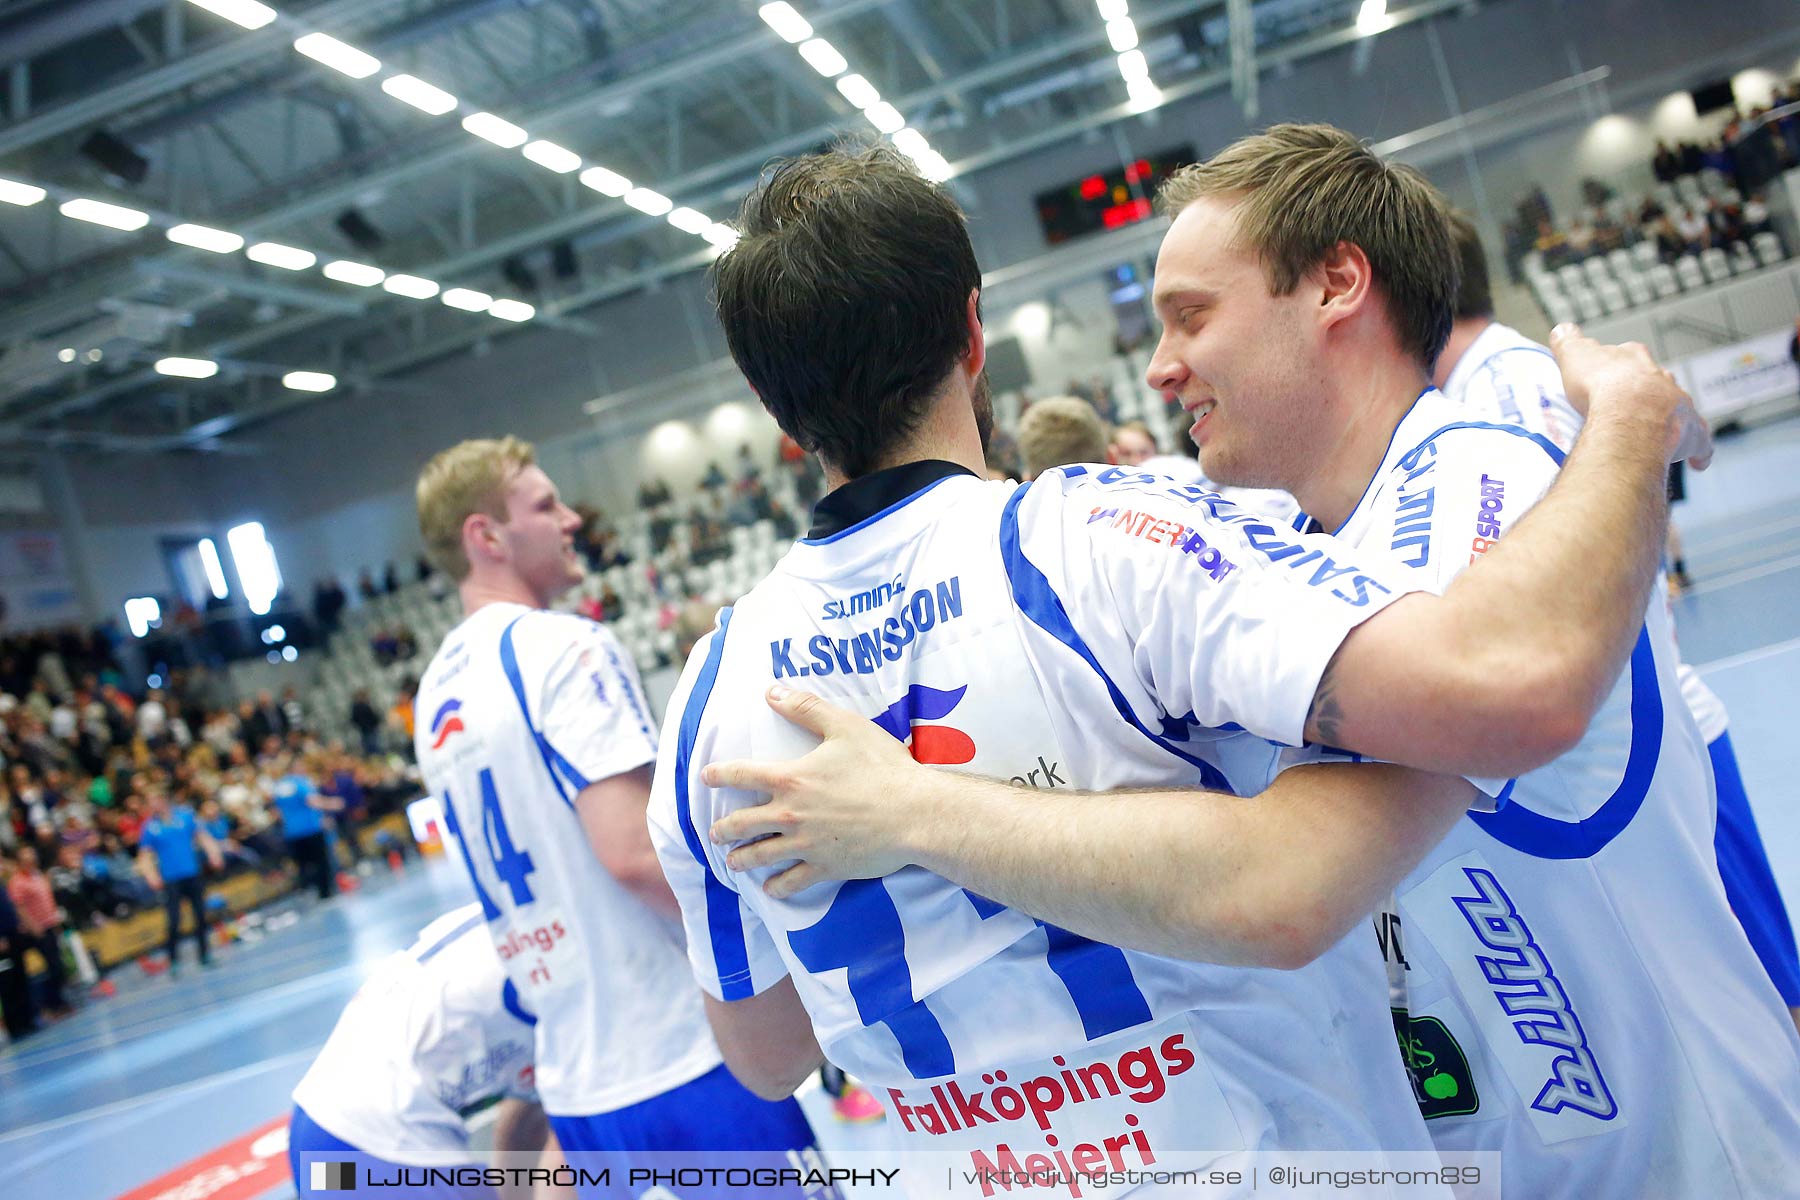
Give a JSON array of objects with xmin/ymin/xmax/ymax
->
[{"xmin": 652, "ymin": 462, "xmax": 1429, "ymax": 1194}]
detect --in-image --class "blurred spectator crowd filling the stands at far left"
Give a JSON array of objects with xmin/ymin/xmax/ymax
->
[{"xmin": 0, "ymin": 631, "xmax": 418, "ymax": 1036}]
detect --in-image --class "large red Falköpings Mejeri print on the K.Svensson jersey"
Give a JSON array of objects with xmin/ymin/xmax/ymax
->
[{"xmin": 886, "ymin": 1022, "xmax": 1217, "ymax": 1198}]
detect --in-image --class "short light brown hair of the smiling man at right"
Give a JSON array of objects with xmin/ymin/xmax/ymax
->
[{"xmin": 1157, "ymin": 124, "xmax": 1462, "ymax": 367}]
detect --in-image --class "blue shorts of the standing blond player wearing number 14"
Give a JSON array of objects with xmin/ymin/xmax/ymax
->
[{"xmin": 551, "ymin": 1067, "xmax": 837, "ymax": 1200}]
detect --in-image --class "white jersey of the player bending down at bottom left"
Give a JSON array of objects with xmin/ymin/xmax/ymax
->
[{"xmin": 293, "ymin": 905, "xmax": 535, "ymax": 1166}]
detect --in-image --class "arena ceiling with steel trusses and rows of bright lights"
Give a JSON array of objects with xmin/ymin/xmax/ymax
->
[{"xmin": 0, "ymin": 0, "xmax": 1467, "ymax": 452}]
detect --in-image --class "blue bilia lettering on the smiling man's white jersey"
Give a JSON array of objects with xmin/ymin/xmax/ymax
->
[{"xmin": 1451, "ymin": 867, "xmax": 1618, "ymax": 1121}]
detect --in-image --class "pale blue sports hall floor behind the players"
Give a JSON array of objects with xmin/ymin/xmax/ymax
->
[{"xmin": 10, "ymin": 408, "xmax": 1800, "ymax": 1200}]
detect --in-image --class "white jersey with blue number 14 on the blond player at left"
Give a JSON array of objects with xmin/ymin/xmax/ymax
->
[{"xmin": 416, "ymin": 604, "xmax": 720, "ymax": 1117}]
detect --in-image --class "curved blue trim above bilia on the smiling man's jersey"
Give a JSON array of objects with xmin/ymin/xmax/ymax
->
[{"xmin": 1469, "ymin": 630, "xmax": 1663, "ymax": 858}]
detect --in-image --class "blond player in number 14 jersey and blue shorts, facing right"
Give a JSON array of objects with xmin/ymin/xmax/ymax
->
[{"xmin": 416, "ymin": 437, "xmax": 812, "ymax": 1196}]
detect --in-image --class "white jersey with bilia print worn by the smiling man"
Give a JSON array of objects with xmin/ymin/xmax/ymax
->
[{"xmin": 1292, "ymin": 390, "xmax": 1800, "ymax": 1200}]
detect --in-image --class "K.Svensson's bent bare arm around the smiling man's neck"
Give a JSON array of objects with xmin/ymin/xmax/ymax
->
[{"xmin": 1307, "ymin": 326, "xmax": 1712, "ymax": 777}]
